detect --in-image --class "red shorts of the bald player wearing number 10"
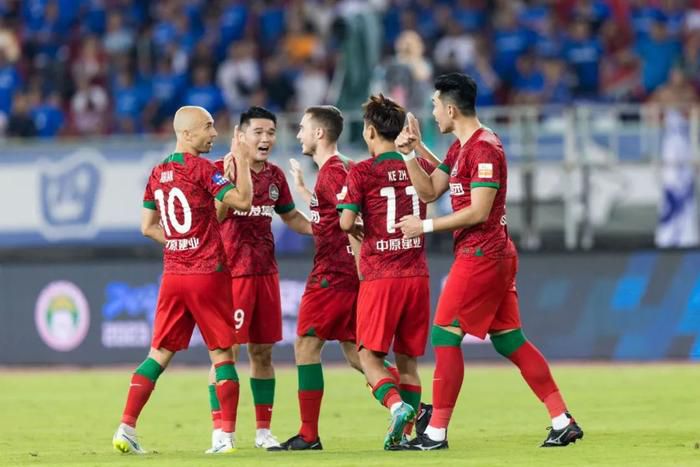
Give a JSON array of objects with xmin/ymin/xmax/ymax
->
[{"xmin": 151, "ymin": 272, "xmax": 236, "ymax": 352}]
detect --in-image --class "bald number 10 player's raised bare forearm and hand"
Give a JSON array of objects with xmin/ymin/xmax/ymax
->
[{"xmin": 217, "ymin": 125, "xmax": 253, "ymax": 212}]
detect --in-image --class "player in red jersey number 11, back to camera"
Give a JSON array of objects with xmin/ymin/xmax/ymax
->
[{"xmin": 337, "ymin": 94, "xmax": 431, "ymax": 449}]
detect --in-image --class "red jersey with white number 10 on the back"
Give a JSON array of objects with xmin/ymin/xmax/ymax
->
[{"xmin": 143, "ymin": 153, "xmax": 234, "ymax": 274}]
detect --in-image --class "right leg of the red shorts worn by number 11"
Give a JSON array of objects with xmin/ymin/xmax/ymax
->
[{"xmin": 394, "ymin": 277, "xmax": 430, "ymax": 357}]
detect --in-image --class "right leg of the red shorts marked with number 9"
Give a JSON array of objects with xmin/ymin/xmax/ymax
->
[{"xmin": 248, "ymin": 274, "xmax": 282, "ymax": 344}]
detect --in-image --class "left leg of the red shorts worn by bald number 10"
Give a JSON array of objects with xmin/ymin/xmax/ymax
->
[{"xmin": 151, "ymin": 274, "xmax": 195, "ymax": 352}]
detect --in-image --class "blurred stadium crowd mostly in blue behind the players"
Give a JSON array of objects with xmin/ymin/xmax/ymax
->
[{"xmin": 0, "ymin": 0, "xmax": 700, "ymax": 138}]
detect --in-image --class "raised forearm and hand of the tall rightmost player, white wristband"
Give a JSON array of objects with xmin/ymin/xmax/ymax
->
[{"xmin": 395, "ymin": 112, "xmax": 449, "ymax": 203}]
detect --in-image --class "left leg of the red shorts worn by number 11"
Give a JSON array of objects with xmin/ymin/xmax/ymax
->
[{"xmin": 356, "ymin": 278, "xmax": 403, "ymax": 354}]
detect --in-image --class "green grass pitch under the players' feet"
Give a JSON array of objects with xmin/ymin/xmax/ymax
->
[{"xmin": 0, "ymin": 364, "xmax": 700, "ymax": 467}]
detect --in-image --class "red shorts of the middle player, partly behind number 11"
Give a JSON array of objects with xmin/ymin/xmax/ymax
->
[{"xmin": 297, "ymin": 288, "xmax": 357, "ymax": 342}]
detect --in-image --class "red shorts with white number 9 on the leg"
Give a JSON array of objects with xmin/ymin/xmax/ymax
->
[{"xmin": 231, "ymin": 273, "xmax": 282, "ymax": 344}]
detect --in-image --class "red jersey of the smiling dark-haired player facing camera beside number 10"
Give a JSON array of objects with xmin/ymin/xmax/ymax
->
[{"xmin": 216, "ymin": 160, "xmax": 294, "ymax": 277}]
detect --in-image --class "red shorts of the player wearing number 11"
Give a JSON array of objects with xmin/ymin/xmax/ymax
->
[{"xmin": 357, "ymin": 277, "xmax": 430, "ymax": 357}]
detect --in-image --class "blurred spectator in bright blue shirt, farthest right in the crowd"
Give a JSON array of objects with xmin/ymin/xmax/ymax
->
[{"xmin": 636, "ymin": 21, "xmax": 681, "ymax": 93}]
